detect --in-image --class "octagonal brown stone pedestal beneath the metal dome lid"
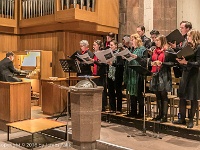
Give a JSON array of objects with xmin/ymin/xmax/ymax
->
[{"xmin": 70, "ymin": 87, "xmax": 103, "ymax": 150}]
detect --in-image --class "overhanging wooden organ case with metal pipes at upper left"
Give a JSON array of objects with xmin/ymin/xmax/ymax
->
[{"xmin": 0, "ymin": 0, "xmax": 119, "ymax": 34}]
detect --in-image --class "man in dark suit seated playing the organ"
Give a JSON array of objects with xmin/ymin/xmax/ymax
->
[{"xmin": 0, "ymin": 52, "xmax": 22, "ymax": 82}]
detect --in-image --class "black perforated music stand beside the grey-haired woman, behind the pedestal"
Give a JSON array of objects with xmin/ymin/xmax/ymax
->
[{"xmin": 56, "ymin": 58, "xmax": 81, "ymax": 120}]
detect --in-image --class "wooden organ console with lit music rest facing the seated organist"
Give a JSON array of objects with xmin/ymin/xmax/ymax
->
[{"xmin": 0, "ymin": 50, "xmax": 52, "ymax": 104}]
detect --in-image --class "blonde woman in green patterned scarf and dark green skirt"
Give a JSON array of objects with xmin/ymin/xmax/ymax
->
[{"xmin": 124, "ymin": 34, "xmax": 147, "ymax": 118}]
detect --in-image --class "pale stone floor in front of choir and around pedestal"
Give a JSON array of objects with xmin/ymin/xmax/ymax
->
[{"xmin": 0, "ymin": 107, "xmax": 200, "ymax": 150}]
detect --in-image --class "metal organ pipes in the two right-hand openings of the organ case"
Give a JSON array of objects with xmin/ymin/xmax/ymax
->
[{"xmin": 20, "ymin": 0, "xmax": 96, "ymax": 19}]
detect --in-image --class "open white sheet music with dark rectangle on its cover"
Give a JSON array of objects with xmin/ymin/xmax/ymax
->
[{"xmin": 95, "ymin": 48, "xmax": 115, "ymax": 64}]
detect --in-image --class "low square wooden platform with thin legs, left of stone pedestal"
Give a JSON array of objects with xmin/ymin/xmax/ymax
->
[{"xmin": 6, "ymin": 118, "xmax": 67, "ymax": 149}]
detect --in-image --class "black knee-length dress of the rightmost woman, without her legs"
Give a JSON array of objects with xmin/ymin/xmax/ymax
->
[{"xmin": 179, "ymin": 45, "xmax": 200, "ymax": 100}]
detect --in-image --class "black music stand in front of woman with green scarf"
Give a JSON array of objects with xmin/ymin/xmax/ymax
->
[{"xmin": 129, "ymin": 65, "xmax": 152, "ymax": 134}]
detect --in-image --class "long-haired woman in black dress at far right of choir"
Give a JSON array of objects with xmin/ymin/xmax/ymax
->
[{"xmin": 174, "ymin": 30, "xmax": 200, "ymax": 128}]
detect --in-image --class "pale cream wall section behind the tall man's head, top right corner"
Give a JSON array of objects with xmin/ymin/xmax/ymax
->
[{"xmin": 177, "ymin": 0, "xmax": 200, "ymax": 31}]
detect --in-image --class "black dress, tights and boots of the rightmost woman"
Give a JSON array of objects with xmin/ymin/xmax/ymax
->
[{"xmin": 174, "ymin": 45, "xmax": 200, "ymax": 125}]
